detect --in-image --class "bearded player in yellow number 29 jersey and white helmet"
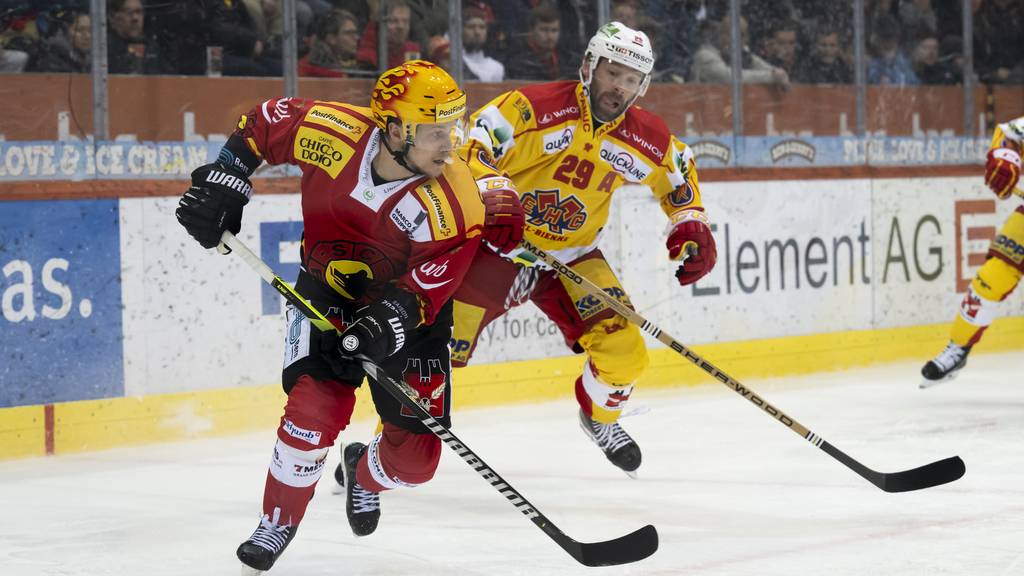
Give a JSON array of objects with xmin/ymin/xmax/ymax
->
[{"xmin": 452, "ymin": 22, "xmax": 716, "ymax": 476}]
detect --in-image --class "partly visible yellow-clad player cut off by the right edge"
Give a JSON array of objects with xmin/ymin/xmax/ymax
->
[{"xmin": 921, "ymin": 117, "xmax": 1024, "ymax": 387}]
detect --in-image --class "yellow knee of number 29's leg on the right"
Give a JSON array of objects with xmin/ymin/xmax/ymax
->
[{"xmin": 580, "ymin": 317, "xmax": 650, "ymax": 385}]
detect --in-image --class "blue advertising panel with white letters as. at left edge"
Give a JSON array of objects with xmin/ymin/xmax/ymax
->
[{"xmin": 0, "ymin": 200, "xmax": 124, "ymax": 408}]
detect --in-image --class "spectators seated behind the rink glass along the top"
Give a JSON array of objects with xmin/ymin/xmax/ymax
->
[{"xmin": 0, "ymin": 0, "xmax": 1024, "ymax": 84}]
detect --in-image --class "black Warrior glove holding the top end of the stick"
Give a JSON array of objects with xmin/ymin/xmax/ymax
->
[{"xmin": 174, "ymin": 163, "xmax": 253, "ymax": 248}]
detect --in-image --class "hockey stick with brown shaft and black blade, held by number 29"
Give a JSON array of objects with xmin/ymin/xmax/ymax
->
[{"xmin": 521, "ymin": 240, "xmax": 966, "ymax": 492}]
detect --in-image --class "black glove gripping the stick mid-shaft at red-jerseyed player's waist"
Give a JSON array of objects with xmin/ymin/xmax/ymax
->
[{"xmin": 338, "ymin": 288, "xmax": 420, "ymax": 364}]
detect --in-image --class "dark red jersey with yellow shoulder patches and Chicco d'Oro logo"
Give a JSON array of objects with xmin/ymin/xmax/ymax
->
[{"xmin": 234, "ymin": 98, "xmax": 483, "ymax": 324}]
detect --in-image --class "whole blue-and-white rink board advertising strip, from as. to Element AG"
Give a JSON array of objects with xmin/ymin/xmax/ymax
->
[{"xmin": 0, "ymin": 177, "xmax": 1024, "ymax": 406}]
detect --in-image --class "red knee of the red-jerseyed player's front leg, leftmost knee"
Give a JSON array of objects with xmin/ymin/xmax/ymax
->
[{"xmin": 278, "ymin": 375, "xmax": 355, "ymax": 451}]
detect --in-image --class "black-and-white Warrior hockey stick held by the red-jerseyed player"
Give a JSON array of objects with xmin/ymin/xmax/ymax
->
[{"xmin": 221, "ymin": 232, "xmax": 657, "ymax": 566}]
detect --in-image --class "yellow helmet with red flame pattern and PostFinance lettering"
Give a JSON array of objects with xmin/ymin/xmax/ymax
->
[{"xmin": 370, "ymin": 60, "xmax": 466, "ymax": 142}]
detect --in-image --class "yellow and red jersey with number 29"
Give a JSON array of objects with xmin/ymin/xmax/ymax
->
[{"xmin": 460, "ymin": 81, "xmax": 703, "ymax": 261}]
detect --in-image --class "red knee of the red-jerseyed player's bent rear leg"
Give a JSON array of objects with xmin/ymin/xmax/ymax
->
[{"xmin": 358, "ymin": 423, "xmax": 441, "ymax": 489}]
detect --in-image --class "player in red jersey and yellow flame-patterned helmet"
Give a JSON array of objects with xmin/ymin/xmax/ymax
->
[{"xmin": 177, "ymin": 60, "xmax": 517, "ymax": 571}]
